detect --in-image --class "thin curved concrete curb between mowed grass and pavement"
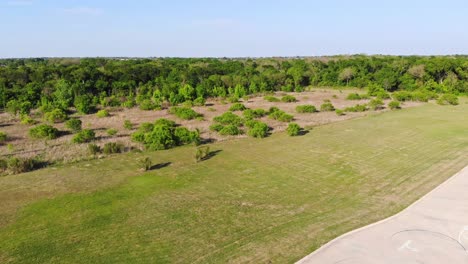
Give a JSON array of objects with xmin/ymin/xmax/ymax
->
[{"xmin": 296, "ymin": 166, "xmax": 468, "ymax": 264}]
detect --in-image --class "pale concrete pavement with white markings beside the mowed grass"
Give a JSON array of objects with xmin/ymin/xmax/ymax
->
[{"xmin": 298, "ymin": 166, "xmax": 468, "ymax": 264}]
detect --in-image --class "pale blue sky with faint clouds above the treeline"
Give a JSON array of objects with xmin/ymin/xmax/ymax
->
[{"xmin": 0, "ymin": 0, "xmax": 468, "ymax": 58}]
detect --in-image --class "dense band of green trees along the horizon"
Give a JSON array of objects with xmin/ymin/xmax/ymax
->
[{"xmin": 0, "ymin": 55, "xmax": 468, "ymax": 114}]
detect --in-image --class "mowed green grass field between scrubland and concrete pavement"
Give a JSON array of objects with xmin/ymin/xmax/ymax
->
[{"xmin": 0, "ymin": 102, "xmax": 468, "ymax": 263}]
